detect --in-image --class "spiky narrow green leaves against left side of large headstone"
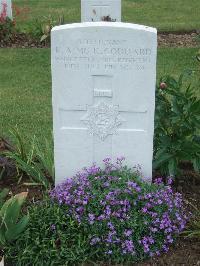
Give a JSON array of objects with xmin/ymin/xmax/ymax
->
[{"xmin": 3, "ymin": 129, "xmax": 54, "ymax": 189}]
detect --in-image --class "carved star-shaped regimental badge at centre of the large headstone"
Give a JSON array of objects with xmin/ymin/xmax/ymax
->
[{"xmin": 81, "ymin": 102, "xmax": 123, "ymax": 141}]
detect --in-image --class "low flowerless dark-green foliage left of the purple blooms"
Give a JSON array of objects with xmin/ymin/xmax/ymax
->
[{"xmin": 5, "ymin": 199, "xmax": 88, "ymax": 266}]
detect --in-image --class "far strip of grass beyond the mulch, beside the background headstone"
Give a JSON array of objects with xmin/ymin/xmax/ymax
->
[{"xmin": 13, "ymin": 0, "xmax": 200, "ymax": 31}]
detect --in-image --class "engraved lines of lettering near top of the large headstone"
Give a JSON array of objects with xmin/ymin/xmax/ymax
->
[{"xmin": 55, "ymin": 39, "xmax": 152, "ymax": 71}]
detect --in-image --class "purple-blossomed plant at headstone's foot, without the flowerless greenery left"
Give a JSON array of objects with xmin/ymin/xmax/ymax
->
[{"xmin": 50, "ymin": 158, "xmax": 188, "ymax": 262}]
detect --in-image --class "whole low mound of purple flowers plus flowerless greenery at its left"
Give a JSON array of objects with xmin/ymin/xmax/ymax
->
[{"xmin": 6, "ymin": 158, "xmax": 188, "ymax": 265}]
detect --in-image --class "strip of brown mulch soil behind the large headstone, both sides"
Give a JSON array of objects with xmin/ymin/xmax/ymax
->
[{"xmin": 0, "ymin": 32, "xmax": 200, "ymax": 48}]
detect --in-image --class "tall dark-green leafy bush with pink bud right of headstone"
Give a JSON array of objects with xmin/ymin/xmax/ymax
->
[{"xmin": 154, "ymin": 75, "xmax": 200, "ymax": 175}]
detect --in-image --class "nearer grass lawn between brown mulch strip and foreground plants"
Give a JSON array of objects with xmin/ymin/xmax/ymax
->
[{"xmin": 0, "ymin": 48, "xmax": 200, "ymax": 148}]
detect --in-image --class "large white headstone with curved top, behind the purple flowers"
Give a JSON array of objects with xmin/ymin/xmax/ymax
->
[{"xmin": 51, "ymin": 22, "xmax": 157, "ymax": 184}]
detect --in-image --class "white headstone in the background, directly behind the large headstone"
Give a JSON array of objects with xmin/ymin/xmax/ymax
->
[{"xmin": 81, "ymin": 0, "xmax": 121, "ymax": 22}]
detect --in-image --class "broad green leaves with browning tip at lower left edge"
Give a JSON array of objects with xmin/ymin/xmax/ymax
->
[{"xmin": 0, "ymin": 190, "xmax": 29, "ymax": 247}]
